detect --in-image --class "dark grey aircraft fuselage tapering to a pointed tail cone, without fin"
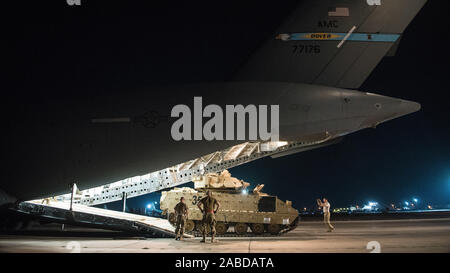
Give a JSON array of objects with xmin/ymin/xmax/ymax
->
[{"xmin": 0, "ymin": 82, "xmax": 420, "ymax": 200}]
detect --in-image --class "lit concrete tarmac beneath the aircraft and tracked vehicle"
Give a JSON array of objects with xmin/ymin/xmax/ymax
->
[{"xmin": 0, "ymin": 218, "xmax": 450, "ymax": 253}]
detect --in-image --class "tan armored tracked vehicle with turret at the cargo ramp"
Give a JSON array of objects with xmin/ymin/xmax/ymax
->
[{"xmin": 160, "ymin": 170, "xmax": 299, "ymax": 235}]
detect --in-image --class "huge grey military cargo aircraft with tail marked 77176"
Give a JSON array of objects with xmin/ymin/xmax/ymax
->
[{"xmin": 0, "ymin": 0, "xmax": 426, "ymax": 204}]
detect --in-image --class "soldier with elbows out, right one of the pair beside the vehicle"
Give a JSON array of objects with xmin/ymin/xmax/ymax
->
[{"xmin": 197, "ymin": 191, "xmax": 220, "ymax": 243}]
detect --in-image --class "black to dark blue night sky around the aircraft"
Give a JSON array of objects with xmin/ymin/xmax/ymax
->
[{"xmin": 2, "ymin": 0, "xmax": 450, "ymax": 208}]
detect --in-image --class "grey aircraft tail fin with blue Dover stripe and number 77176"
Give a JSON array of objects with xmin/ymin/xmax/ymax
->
[{"xmin": 234, "ymin": 0, "xmax": 427, "ymax": 89}]
